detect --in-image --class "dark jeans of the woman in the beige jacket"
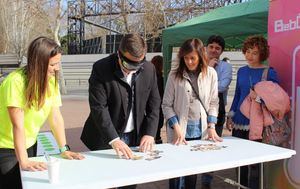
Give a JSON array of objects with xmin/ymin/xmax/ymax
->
[{"xmin": 169, "ymin": 137, "xmax": 201, "ymax": 189}]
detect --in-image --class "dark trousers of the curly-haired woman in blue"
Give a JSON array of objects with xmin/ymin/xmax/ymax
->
[{"xmin": 232, "ymin": 129, "xmax": 261, "ymax": 189}]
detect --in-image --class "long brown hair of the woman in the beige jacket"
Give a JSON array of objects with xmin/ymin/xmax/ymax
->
[{"xmin": 176, "ymin": 38, "xmax": 208, "ymax": 79}]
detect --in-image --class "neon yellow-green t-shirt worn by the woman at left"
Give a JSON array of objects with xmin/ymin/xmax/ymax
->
[{"xmin": 0, "ymin": 69, "xmax": 62, "ymax": 149}]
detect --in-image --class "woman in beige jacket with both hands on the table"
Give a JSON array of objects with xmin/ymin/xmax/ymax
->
[{"xmin": 162, "ymin": 39, "xmax": 222, "ymax": 189}]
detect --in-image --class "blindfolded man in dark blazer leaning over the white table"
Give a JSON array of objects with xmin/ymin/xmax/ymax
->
[{"xmin": 81, "ymin": 34, "xmax": 160, "ymax": 187}]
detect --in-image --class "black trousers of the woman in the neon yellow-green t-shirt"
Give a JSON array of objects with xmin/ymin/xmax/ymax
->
[{"xmin": 0, "ymin": 143, "xmax": 37, "ymax": 189}]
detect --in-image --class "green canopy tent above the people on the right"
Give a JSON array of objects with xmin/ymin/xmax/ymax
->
[{"xmin": 162, "ymin": 0, "xmax": 269, "ymax": 78}]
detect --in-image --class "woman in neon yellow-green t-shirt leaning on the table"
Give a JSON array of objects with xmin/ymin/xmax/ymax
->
[{"xmin": 0, "ymin": 37, "xmax": 84, "ymax": 188}]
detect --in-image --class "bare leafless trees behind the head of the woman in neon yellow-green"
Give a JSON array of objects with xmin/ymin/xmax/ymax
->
[{"xmin": 0, "ymin": 0, "xmax": 66, "ymax": 94}]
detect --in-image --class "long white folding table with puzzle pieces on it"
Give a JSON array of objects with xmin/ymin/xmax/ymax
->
[{"xmin": 21, "ymin": 137, "xmax": 296, "ymax": 189}]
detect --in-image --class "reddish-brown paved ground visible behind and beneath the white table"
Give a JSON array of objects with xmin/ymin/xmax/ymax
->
[{"xmin": 42, "ymin": 90, "xmax": 236, "ymax": 189}]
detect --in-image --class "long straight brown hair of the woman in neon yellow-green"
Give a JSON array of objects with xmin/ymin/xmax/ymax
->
[{"xmin": 24, "ymin": 37, "xmax": 61, "ymax": 110}]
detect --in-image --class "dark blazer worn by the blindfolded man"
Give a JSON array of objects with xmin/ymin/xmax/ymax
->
[{"xmin": 81, "ymin": 54, "xmax": 160, "ymax": 150}]
